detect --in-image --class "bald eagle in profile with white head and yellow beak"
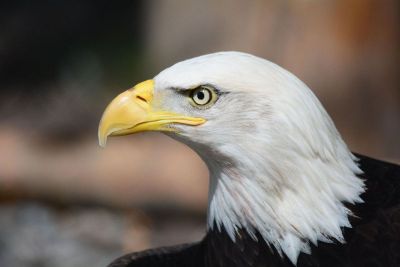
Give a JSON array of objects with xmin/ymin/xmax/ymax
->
[{"xmin": 98, "ymin": 52, "xmax": 400, "ymax": 267}]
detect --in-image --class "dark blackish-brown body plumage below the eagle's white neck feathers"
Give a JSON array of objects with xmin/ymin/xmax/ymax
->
[{"xmin": 109, "ymin": 155, "xmax": 400, "ymax": 267}]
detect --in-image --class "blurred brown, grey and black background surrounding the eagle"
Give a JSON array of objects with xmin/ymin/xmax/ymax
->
[{"xmin": 0, "ymin": 0, "xmax": 400, "ymax": 267}]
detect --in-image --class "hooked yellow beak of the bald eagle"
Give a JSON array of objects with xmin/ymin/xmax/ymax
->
[{"xmin": 98, "ymin": 80, "xmax": 206, "ymax": 147}]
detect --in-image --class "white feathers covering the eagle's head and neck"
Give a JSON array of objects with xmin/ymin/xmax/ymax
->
[{"xmin": 154, "ymin": 52, "xmax": 365, "ymax": 264}]
